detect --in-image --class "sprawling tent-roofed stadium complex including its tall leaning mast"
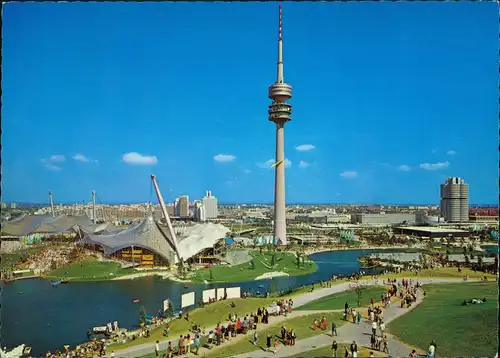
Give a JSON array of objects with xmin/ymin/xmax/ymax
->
[{"xmin": 2, "ymin": 175, "xmax": 234, "ymax": 267}]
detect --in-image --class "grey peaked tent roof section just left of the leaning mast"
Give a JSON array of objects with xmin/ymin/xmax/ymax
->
[{"xmin": 81, "ymin": 216, "xmax": 175, "ymax": 263}]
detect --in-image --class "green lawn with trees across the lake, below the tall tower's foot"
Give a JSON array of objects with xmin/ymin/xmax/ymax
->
[{"xmin": 191, "ymin": 250, "xmax": 317, "ymax": 282}]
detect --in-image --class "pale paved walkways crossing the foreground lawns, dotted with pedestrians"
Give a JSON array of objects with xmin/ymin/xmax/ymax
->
[{"xmin": 106, "ymin": 277, "xmax": 466, "ymax": 358}]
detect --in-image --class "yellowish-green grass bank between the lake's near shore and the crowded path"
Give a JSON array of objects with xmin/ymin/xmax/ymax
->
[{"xmin": 109, "ymin": 298, "xmax": 273, "ymax": 351}]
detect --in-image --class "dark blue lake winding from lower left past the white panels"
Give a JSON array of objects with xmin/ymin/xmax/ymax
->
[{"xmin": 0, "ymin": 250, "xmax": 386, "ymax": 355}]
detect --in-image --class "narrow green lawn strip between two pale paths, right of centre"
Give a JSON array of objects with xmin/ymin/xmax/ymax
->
[{"xmin": 297, "ymin": 286, "xmax": 386, "ymax": 311}]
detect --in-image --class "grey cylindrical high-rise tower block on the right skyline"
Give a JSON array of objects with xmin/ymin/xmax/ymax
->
[{"xmin": 441, "ymin": 177, "xmax": 469, "ymax": 222}]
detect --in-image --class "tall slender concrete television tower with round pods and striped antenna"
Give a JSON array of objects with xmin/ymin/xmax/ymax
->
[{"xmin": 269, "ymin": 5, "xmax": 292, "ymax": 245}]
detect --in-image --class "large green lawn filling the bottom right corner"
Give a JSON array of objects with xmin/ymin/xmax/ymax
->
[{"xmin": 388, "ymin": 282, "xmax": 498, "ymax": 357}]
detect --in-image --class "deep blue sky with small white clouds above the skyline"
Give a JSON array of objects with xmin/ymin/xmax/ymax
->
[{"xmin": 2, "ymin": 2, "xmax": 498, "ymax": 204}]
